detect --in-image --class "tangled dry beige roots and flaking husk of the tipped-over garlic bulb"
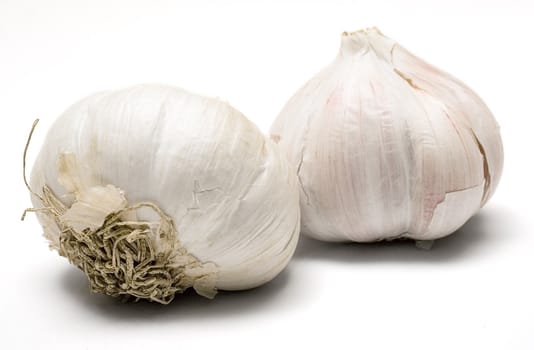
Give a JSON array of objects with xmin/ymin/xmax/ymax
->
[{"xmin": 23, "ymin": 124, "xmax": 217, "ymax": 304}]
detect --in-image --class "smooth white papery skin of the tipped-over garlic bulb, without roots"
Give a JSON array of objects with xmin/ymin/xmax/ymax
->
[{"xmin": 30, "ymin": 85, "xmax": 300, "ymax": 290}]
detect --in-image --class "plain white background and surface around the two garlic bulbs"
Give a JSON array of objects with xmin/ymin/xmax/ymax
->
[{"xmin": 0, "ymin": 0, "xmax": 534, "ymax": 349}]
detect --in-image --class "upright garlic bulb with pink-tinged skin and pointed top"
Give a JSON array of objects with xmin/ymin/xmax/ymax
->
[{"xmin": 271, "ymin": 28, "xmax": 503, "ymax": 242}]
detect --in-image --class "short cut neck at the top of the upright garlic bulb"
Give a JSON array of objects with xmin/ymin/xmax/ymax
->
[{"xmin": 339, "ymin": 27, "xmax": 396, "ymax": 63}]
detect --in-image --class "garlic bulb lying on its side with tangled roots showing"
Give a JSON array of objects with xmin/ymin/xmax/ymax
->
[{"xmin": 29, "ymin": 85, "xmax": 300, "ymax": 303}]
